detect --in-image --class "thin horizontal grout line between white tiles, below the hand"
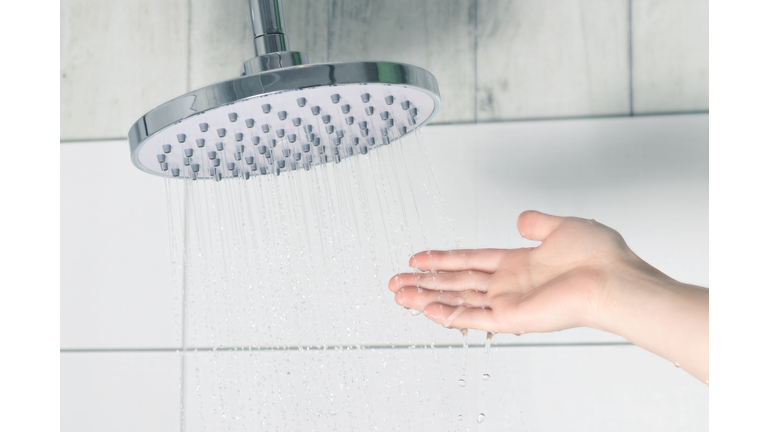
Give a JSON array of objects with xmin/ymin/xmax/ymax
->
[{"xmin": 59, "ymin": 342, "xmax": 634, "ymax": 353}]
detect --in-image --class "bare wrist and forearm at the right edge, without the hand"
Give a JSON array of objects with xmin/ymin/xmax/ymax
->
[{"xmin": 595, "ymin": 261, "xmax": 709, "ymax": 384}]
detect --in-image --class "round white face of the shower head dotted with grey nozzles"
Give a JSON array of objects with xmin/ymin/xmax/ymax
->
[{"xmin": 129, "ymin": 63, "xmax": 440, "ymax": 180}]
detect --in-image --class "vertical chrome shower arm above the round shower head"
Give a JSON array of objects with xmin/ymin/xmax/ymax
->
[{"xmin": 240, "ymin": 0, "xmax": 309, "ymax": 76}]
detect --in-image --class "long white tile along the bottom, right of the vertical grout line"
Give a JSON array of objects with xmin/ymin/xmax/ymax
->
[{"xmin": 185, "ymin": 345, "xmax": 708, "ymax": 431}]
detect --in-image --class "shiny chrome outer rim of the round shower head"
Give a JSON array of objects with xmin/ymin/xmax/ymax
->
[{"xmin": 128, "ymin": 62, "xmax": 440, "ymax": 153}]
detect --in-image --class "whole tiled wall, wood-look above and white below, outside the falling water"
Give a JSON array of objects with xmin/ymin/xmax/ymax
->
[{"xmin": 61, "ymin": 0, "xmax": 709, "ymax": 431}]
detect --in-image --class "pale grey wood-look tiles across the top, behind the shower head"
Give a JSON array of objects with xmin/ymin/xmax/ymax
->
[{"xmin": 61, "ymin": 0, "xmax": 709, "ymax": 141}]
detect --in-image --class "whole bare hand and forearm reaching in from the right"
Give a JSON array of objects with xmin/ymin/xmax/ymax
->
[{"xmin": 389, "ymin": 211, "xmax": 709, "ymax": 385}]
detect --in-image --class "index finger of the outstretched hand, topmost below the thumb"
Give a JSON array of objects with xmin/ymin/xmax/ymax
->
[{"xmin": 408, "ymin": 249, "xmax": 504, "ymax": 273}]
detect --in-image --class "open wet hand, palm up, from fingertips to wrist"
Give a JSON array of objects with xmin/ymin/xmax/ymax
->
[{"xmin": 389, "ymin": 211, "xmax": 639, "ymax": 334}]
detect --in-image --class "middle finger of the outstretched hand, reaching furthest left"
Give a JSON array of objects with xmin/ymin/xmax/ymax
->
[{"xmin": 389, "ymin": 270, "xmax": 491, "ymax": 292}]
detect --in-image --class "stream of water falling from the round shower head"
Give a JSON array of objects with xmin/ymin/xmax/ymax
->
[{"xmin": 164, "ymin": 131, "xmax": 524, "ymax": 431}]
